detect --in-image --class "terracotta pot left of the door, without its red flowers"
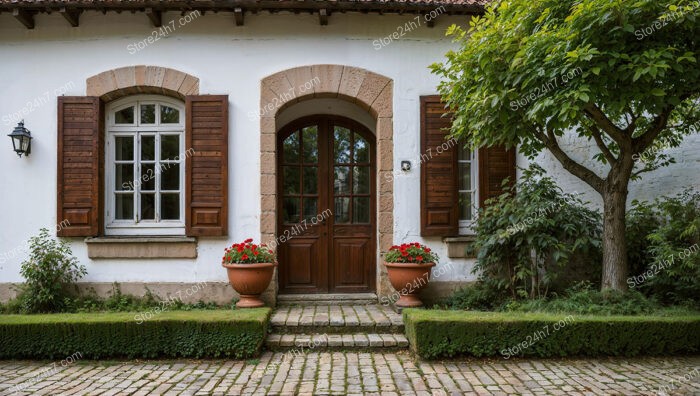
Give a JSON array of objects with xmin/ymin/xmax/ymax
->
[{"xmin": 221, "ymin": 263, "xmax": 277, "ymax": 308}]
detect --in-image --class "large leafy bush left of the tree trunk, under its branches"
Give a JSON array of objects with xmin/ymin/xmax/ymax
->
[{"xmin": 474, "ymin": 164, "xmax": 601, "ymax": 298}]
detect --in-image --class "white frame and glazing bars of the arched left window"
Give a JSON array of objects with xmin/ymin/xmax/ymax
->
[{"xmin": 105, "ymin": 95, "xmax": 185, "ymax": 236}]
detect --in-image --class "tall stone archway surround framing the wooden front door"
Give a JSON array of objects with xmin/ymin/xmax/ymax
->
[{"xmin": 259, "ymin": 65, "xmax": 394, "ymax": 295}]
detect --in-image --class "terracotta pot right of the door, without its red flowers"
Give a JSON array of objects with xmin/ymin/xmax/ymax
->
[{"xmin": 384, "ymin": 262, "xmax": 435, "ymax": 308}]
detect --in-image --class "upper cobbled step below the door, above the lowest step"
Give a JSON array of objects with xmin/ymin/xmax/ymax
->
[{"xmin": 270, "ymin": 305, "xmax": 404, "ymax": 334}]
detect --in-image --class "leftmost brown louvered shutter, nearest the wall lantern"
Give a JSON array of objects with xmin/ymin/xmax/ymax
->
[{"xmin": 56, "ymin": 96, "xmax": 104, "ymax": 237}]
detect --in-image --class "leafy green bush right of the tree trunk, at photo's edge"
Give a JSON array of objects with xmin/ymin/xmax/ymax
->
[{"xmin": 627, "ymin": 191, "xmax": 700, "ymax": 305}]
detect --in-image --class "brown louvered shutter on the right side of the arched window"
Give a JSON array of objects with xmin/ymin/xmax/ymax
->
[{"xmin": 185, "ymin": 95, "xmax": 228, "ymax": 236}]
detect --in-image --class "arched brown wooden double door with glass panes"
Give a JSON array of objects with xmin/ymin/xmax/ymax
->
[{"xmin": 277, "ymin": 115, "xmax": 376, "ymax": 293}]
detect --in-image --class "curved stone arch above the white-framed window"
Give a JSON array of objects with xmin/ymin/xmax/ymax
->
[{"xmin": 86, "ymin": 65, "xmax": 199, "ymax": 102}]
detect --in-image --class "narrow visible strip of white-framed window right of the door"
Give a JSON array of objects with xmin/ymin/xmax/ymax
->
[{"xmin": 457, "ymin": 144, "xmax": 479, "ymax": 235}]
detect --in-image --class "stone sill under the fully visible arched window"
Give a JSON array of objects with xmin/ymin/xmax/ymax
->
[{"xmin": 85, "ymin": 237, "xmax": 197, "ymax": 259}]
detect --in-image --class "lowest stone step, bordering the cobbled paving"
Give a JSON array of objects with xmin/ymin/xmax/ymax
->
[{"xmin": 265, "ymin": 333, "xmax": 408, "ymax": 353}]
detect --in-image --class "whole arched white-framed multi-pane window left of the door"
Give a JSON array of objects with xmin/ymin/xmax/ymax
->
[{"xmin": 105, "ymin": 96, "xmax": 187, "ymax": 235}]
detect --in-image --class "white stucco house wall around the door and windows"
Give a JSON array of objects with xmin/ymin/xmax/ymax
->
[{"xmin": 0, "ymin": 12, "xmax": 700, "ymax": 290}]
